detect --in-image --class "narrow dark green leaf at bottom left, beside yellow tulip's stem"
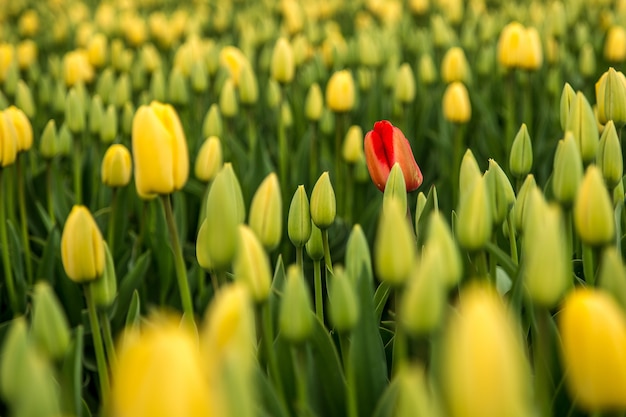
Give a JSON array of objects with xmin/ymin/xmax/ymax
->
[{"xmin": 59, "ymin": 326, "xmax": 84, "ymax": 417}]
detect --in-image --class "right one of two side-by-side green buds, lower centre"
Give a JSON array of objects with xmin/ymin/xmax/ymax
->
[{"xmin": 328, "ymin": 267, "xmax": 359, "ymax": 333}]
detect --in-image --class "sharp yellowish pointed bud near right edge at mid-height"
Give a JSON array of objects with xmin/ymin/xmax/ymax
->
[{"xmin": 574, "ymin": 165, "xmax": 615, "ymax": 246}]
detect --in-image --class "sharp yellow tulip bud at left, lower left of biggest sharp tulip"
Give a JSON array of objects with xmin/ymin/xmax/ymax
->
[{"xmin": 61, "ymin": 205, "xmax": 104, "ymax": 283}]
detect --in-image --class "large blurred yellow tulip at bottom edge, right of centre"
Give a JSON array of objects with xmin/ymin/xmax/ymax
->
[{"xmin": 441, "ymin": 285, "xmax": 533, "ymax": 417}]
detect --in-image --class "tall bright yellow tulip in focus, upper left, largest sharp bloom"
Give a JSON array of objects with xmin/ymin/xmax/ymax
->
[{"xmin": 132, "ymin": 101, "xmax": 189, "ymax": 196}]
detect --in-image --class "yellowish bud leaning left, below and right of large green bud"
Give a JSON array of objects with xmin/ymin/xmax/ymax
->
[{"xmin": 233, "ymin": 224, "xmax": 272, "ymax": 303}]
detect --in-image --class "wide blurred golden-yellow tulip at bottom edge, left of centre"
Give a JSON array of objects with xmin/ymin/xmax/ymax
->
[{"xmin": 111, "ymin": 317, "xmax": 217, "ymax": 417}]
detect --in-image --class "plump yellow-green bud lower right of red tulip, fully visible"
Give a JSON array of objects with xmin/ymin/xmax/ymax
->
[{"xmin": 455, "ymin": 173, "xmax": 493, "ymax": 251}]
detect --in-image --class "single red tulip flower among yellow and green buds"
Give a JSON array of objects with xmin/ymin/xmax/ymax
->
[{"xmin": 363, "ymin": 120, "xmax": 423, "ymax": 192}]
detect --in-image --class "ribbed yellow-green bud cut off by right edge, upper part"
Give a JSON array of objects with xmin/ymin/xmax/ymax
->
[{"xmin": 596, "ymin": 67, "xmax": 626, "ymax": 128}]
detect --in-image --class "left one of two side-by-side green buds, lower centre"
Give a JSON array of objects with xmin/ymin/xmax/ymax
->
[{"xmin": 278, "ymin": 265, "xmax": 314, "ymax": 344}]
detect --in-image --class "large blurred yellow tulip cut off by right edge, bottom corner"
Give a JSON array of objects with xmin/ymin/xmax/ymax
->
[{"xmin": 557, "ymin": 288, "xmax": 626, "ymax": 412}]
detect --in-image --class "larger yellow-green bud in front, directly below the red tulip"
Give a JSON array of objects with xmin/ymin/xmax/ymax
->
[{"xmin": 374, "ymin": 200, "xmax": 416, "ymax": 286}]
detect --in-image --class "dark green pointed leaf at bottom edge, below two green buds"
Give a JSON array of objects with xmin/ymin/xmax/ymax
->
[{"xmin": 307, "ymin": 312, "xmax": 346, "ymax": 417}]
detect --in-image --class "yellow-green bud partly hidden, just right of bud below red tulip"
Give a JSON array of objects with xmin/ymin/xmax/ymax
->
[{"xmin": 427, "ymin": 211, "xmax": 463, "ymax": 288}]
